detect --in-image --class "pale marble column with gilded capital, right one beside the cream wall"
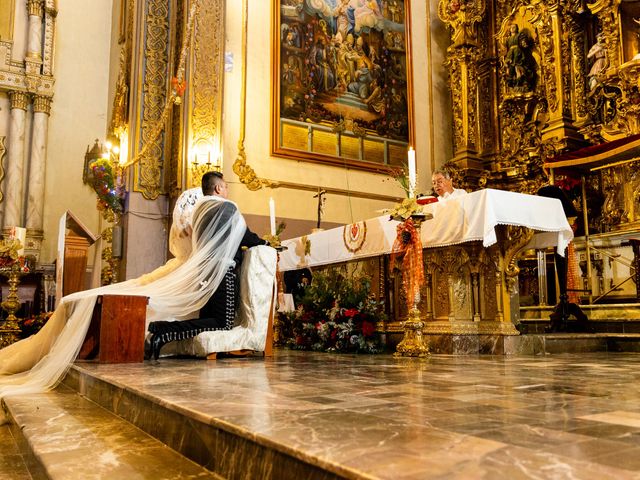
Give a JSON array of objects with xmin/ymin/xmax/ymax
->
[{"xmin": 26, "ymin": 95, "xmax": 51, "ymax": 257}]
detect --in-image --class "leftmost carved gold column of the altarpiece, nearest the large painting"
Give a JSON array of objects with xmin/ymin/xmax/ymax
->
[{"xmin": 438, "ymin": 0, "xmax": 485, "ymax": 178}]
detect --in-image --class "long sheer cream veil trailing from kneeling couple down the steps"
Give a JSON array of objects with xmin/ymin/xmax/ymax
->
[{"xmin": 0, "ymin": 196, "xmax": 246, "ymax": 404}]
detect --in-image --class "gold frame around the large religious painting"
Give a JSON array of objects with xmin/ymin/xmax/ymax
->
[{"xmin": 271, "ymin": 0, "xmax": 415, "ymax": 173}]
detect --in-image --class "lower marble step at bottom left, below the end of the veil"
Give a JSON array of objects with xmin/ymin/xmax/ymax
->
[{"xmin": 4, "ymin": 386, "xmax": 223, "ymax": 480}]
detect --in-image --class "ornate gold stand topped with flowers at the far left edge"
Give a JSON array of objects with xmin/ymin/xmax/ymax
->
[{"xmin": 0, "ymin": 238, "xmax": 29, "ymax": 348}]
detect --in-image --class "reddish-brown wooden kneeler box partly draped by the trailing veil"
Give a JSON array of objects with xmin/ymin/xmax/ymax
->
[{"xmin": 78, "ymin": 295, "xmax": 149, "ymax": 363}]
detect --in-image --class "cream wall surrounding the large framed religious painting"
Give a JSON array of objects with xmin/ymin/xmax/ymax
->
[{"xmin": 223, "ymin": 0, "xmax": 451, "ymax": 233}]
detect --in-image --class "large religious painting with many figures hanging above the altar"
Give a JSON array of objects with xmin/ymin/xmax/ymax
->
[{"xmin": 271, "ymin": 0, "xmax": 413, "ymax": 171}]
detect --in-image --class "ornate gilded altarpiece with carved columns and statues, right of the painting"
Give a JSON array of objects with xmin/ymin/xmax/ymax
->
[{"xmin": 438, "ymin": 0, "xmax": 640, "ymax": 231}]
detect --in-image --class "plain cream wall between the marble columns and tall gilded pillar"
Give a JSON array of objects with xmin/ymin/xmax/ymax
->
[{"xmin": 41, "ymin": 0, "xmax": 112, "ymax": 263}]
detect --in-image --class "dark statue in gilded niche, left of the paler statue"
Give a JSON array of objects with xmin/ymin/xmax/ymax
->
[{"xmin": 505, "ymin": 23, "xmax": 538, "ymax": 92}]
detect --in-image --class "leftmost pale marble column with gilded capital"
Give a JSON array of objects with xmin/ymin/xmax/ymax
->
[{"xmin": 3, "ymin": 90, "xmax": 29, "ymax": 232}]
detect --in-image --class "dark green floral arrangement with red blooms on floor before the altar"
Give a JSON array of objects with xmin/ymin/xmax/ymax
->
[{"xmin": 280, "ymin": 271, "xmax": 386, "ymax": 353}]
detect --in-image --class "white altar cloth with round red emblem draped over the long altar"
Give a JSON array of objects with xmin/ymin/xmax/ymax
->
[{"xmin": 279, "ymin": 189, "xmax": 573, "ymax": 271}]
